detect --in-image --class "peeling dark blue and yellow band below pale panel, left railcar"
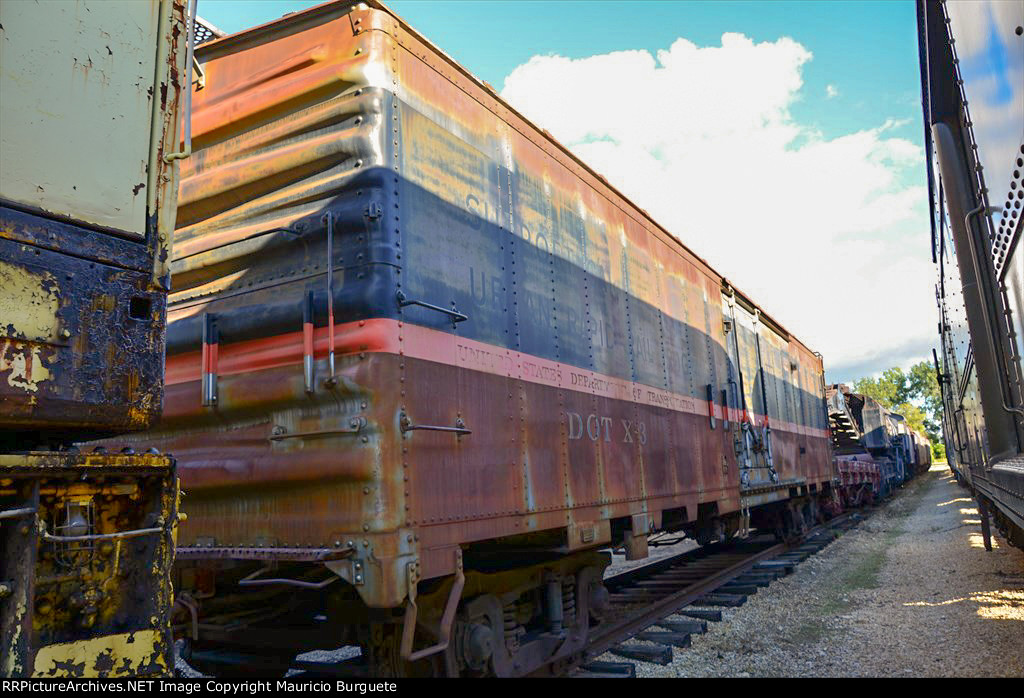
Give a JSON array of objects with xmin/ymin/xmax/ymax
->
[{"xmin": 0, "ymin": 231, "xmax": 165, "ymax": 440}]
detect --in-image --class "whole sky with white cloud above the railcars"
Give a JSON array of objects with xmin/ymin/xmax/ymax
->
[{"xmin": 199, "ymin": 0, "xmax": 937, "ymax": 382}]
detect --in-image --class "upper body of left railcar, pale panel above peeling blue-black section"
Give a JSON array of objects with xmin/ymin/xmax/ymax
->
[{"xmin": 0, "ymin": 0, "xmax": 186, "ymax": 440}]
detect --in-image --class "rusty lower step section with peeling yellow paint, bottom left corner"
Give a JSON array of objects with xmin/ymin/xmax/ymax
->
[{"xmin": 0, "ymin": 452, "xmax": 178, "ymax": 677}]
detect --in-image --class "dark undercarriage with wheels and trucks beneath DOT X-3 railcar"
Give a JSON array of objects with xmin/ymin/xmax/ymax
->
[{"xmin": 173, "ymin": 491, "xmax": 830, "ymax": 678}]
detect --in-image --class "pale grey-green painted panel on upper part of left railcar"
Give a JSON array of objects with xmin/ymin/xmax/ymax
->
[{"xmin": 0, "ymin": 0, "xmax": 161, "ymax": 235}]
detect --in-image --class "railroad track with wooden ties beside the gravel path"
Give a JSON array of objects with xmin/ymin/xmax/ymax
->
[{"xmin": 557, "ymin": 512, "xmax": 863, "ymax": 678}]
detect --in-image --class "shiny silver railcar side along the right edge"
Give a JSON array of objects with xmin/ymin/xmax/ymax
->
[{"xmin": 918, "ymin": 0, "xmax": 1024, "ymax": 547}]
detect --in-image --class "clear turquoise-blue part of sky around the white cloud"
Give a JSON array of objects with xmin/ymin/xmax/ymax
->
[{"xmin": 199, "ymin": 0, "xmax": 921, "ymax": 142}]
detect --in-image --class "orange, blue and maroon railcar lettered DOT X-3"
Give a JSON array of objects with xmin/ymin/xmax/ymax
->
[{"xmin": 140, "ymin": 2, "xmax": 834, "ymax": 675}]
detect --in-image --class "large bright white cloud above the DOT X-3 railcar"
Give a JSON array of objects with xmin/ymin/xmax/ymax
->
[{"xmin": 502, "ymin": 34, "xmax": 936, "ymax": 379}]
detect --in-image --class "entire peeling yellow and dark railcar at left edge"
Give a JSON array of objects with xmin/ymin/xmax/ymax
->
[{"xmin": 0, "ymin": 0, "xmax": 195, "ymax": 677}]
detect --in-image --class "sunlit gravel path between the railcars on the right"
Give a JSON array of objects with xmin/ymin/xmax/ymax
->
[{"xmin": 634, "ymin": 465, "xmax": 1024, "ymax": 677}]
